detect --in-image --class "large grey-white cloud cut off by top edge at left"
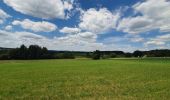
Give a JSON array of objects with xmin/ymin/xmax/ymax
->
[{"xmin": 3, "ymin": 0, "xmax": 73, "ymax": 19}]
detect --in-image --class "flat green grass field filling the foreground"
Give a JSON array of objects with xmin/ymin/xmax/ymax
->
[{"xmin": 0, "ymin": 59, "xmax": 170, "ymax": 100}]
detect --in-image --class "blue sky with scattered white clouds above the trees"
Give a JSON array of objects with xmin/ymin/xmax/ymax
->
[{"xmin": 0, "ymin": 0, "xmax": 170, "ymax": 52}]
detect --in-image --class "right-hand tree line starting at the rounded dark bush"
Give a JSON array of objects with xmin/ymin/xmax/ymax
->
[{"xmin": 91, "ymin": 49, "xmax": 170, "ymax": 59}]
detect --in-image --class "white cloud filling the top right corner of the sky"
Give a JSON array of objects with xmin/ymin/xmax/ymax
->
[{"xmin": 133, "ymin": 0, "xmax": 170, "ymax": 20}]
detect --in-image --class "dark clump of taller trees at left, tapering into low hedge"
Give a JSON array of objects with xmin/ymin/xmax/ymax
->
[{"xmin": 0, "ymin": 45, "xmax": 74, "ymax": 60}]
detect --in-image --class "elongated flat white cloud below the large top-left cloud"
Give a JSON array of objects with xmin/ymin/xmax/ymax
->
[{"xmin": 12, "ymin": 19, "xmax": 57, "ymax": 32}]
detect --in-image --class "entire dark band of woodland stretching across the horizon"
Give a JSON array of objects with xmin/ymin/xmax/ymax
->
[{"xmin": 0, "ymin": 45, "xmax": 170, "ymax": 60}]
